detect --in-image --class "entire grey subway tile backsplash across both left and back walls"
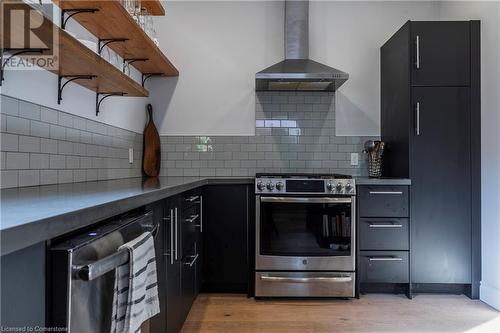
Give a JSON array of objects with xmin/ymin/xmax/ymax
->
[{"xmin": 0, "ymin": 92, "xmax": 376, "ymax": 188}]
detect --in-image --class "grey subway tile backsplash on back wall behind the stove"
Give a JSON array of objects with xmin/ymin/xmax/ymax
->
[{"xmin": 161, "ymin": 92, "xmax": 376, "ymax": 177}]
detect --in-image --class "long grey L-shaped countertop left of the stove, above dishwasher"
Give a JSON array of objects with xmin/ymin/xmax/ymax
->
[{"xmin": 0, "ymin": 177, "xmax": 250, "ymax": 255}]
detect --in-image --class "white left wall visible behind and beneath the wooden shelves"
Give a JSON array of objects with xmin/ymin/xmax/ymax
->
[{"xmin": 0, "ymin": 6, "xmax": 148, "ymax": 133}]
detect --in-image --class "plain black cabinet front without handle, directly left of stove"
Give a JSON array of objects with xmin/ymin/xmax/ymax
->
[{"xmin": 203, "ymin": 185, "xmax": 251, "ymax": 293}]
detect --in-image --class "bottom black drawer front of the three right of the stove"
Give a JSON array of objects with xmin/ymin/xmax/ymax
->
[{"xmin": 359, "ymin": 251, "xmax": 409, "ymax": 283}]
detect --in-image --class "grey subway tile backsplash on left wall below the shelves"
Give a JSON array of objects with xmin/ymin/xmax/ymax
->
[{"xmin": 0, "ymin": 95, "xmax": 142, "ymax": 188}]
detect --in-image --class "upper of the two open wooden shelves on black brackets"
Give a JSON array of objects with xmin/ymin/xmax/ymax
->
[{"xmin": 54, "ymin": 0, "xmax": 179, "ymax": 76}]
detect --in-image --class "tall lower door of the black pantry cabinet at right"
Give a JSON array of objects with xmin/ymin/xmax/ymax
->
[{"xmin": 411, "ymin": 87, "xmax": 472, "ymax": 284}]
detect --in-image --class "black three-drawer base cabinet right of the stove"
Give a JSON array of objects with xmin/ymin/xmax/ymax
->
[{"xmin": 357, "ymin": 185, "xmax": 412, "ymax": 298}]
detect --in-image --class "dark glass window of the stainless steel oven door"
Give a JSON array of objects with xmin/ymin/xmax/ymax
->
[{"xmin": 260, "ymin": 202, "xmax": 352, "ymax": 257}]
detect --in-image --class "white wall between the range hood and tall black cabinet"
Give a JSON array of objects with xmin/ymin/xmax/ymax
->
[{"xmin": 309, "ymin": 1, "xmax": 437, "ymax": 136}]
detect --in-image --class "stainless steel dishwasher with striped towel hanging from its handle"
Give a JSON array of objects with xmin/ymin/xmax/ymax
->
[{"xmin": 47, "ymin": 212, "xmax": 159, "ymax": 333}]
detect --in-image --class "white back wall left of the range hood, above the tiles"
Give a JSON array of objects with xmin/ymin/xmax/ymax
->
[{"xmin": 151, "ymin": 1, "xmax": 283, "ymax": 135}]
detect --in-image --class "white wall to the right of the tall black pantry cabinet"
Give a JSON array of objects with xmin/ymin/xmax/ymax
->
[{"xmin": 440, "ymin": 2, "xmax": 500, "ymax": 310}]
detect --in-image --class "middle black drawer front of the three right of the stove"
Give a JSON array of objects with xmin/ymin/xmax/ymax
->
[{"xmin": 358, "ymin": 217, "xmax": 409, "ymax": 250}]
